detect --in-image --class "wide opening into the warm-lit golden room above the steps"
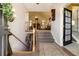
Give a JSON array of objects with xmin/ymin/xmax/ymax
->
[{"xmin": 29, "ymin": 12, "xmax": 51, "ymax": 30}]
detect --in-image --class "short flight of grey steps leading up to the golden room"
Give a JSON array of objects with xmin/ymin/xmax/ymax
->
[{"xmin": 37, "ymin": 31, "xmax": 54, "ymax": 43}]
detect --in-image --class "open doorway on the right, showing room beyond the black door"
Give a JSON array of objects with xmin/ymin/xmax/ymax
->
[{"xmin": 64, "ymin": 3, "xmax": 79, "ymax": 56}]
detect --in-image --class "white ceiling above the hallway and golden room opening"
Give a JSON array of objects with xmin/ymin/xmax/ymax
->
[{"xmin": 24, "ymin": 3, "xmax": 66, "ymax": 11}]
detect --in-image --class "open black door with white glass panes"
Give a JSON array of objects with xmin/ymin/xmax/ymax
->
[{"xmin": 63, "ymin": 8, "xmax": 72, "ymax": 46}]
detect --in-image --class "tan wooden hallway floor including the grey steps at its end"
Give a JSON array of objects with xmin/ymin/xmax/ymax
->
[{"xmin": 12, "ymin": 31, "xmax": 73, "ymax": 56}]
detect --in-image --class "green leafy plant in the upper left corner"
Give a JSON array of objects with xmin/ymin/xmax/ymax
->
[{"xmin": 2, "ymin": 3, "xmax": 14, "ymax": 26}]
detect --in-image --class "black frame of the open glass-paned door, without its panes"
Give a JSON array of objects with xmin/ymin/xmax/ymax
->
[{"xmin": 63, "ymin": 8, "xmax": 72, "ymax": 46}]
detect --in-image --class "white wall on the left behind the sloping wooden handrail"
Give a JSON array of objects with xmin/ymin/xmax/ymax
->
[{"xmin": 8, "ymin": 3, "xmax": 28, "ymax": 52}]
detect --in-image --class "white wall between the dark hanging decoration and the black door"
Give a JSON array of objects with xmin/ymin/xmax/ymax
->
[{"xmin": 51, "ymin": 6, "xmax": 63, "ymax": 46}]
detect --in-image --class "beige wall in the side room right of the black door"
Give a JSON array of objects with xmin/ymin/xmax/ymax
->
[{"xmin": 72, "ymin": 6, "xmax": 79, "ymax": 31}]
